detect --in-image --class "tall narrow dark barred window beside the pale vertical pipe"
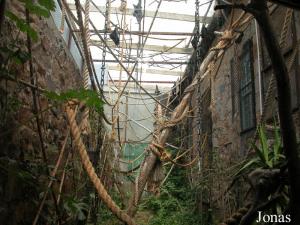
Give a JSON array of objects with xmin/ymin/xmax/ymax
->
[{"xmin": 239, "ymin": 40, "xmax": 256, "ymax": 132}]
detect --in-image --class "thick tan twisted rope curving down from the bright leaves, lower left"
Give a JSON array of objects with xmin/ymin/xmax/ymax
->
[{"xmin": 66, "ymin": 106, "xmax": 136, "ymax": 225}]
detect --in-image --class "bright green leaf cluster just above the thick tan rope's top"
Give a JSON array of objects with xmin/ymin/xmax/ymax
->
[{"xmin": 45, "ymin": 89, "xmax": 103, "ymax": 113}]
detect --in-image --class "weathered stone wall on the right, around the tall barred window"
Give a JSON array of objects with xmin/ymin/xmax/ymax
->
[{"xmin": 192, "ymin": 4, "xmax": 300, "ymax": 220}]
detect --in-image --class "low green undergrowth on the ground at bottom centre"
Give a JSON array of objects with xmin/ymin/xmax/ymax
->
[{"xmin": 141, "ymin": 164, "xmax": 202, "ymax": 225}]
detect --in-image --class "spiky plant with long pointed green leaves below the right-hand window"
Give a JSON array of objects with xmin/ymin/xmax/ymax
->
[{"xmin": 236, "ymin": 124, "xmax": 285, "ymax": 175}]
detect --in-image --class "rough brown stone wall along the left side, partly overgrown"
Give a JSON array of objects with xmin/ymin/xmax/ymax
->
[{"xmin": 0, "ymin": 1, "xmax": 82, "ymax": 225}]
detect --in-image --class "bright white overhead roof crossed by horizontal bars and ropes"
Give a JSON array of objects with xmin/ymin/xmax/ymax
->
[{"xmin": 61, "ymin": 0, "xmax": 213, "ymax": 146}]
